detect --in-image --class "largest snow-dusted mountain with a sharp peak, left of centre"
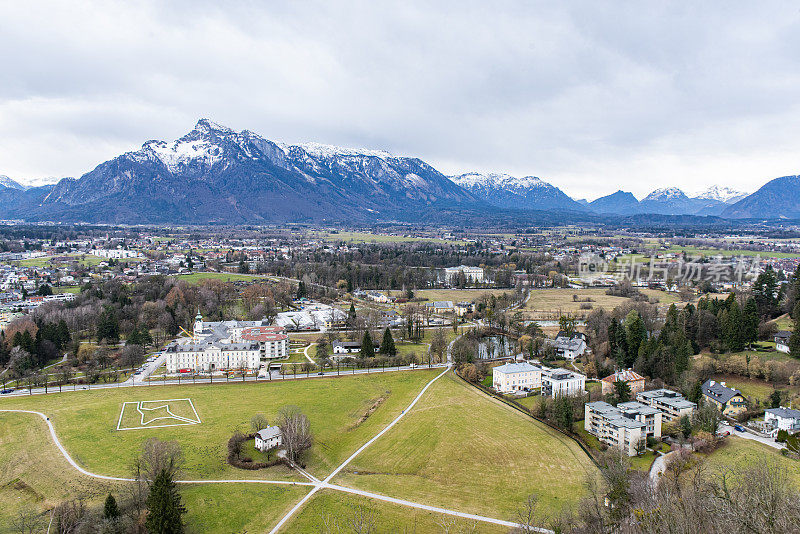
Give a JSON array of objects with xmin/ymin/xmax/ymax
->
[{"xmin": 21, "ymin": 119, "xmax": 480, "ymax": 223}]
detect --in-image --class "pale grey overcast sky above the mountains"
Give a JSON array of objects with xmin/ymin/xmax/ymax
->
[{"xmin": 0, "ymin": 0, "xmax": 800, "ymax": 198}]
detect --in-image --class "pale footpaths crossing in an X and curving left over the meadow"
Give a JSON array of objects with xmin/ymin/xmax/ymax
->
[{"xmin": 0, "ymin": 362, "xmax": 552, "ymax": 534}]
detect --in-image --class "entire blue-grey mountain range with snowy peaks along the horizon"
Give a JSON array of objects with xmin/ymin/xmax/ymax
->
[{"xmin": 0, "ymin": 119, "xmax": 800, "ymax": 224}]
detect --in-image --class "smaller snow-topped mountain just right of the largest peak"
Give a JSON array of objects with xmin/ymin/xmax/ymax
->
[{"xmin": 450, "ymin": 172, "xmax": 586, "ymax": 211}]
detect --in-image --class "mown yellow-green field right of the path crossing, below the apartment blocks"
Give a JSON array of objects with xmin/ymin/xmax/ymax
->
[{"xmin": 335, "ymin": 375, "xmax": 596, "ymax": 520}]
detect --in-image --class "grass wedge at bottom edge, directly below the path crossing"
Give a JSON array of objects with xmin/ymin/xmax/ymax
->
[{"xmin": 282, "ymin": 490, "xmax": 508, "ymax": 534}]
